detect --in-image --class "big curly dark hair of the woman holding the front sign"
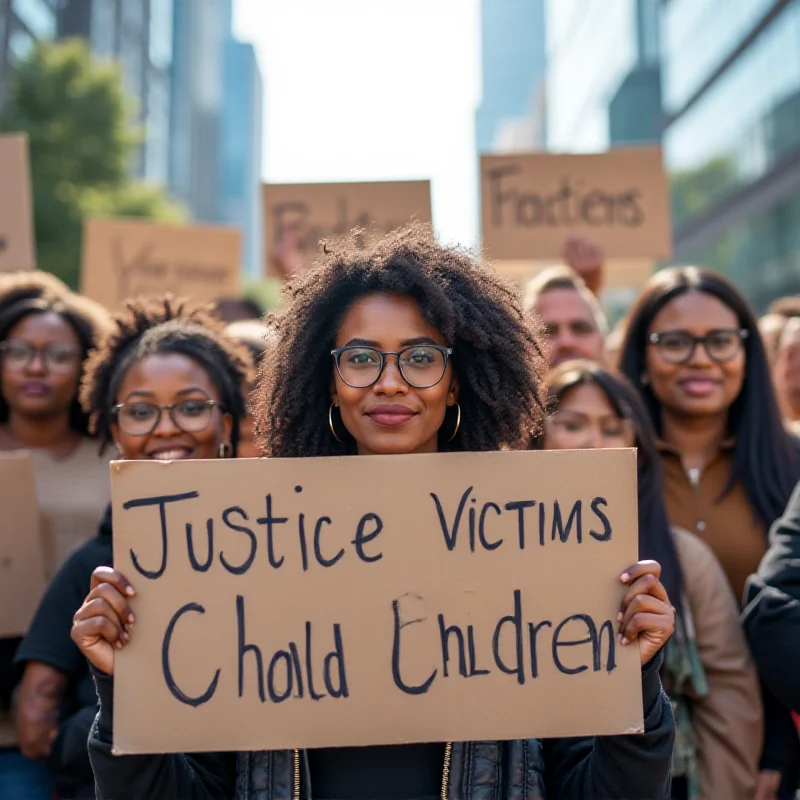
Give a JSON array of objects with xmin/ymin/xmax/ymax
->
[{"xmin": 260, "ymin": 223, "xmax": 546, "ymax": 457}]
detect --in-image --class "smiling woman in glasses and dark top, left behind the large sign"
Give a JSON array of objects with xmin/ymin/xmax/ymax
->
[{"xmin": 17, "ymin": 299, "xmax": 252, "ymax": 800}]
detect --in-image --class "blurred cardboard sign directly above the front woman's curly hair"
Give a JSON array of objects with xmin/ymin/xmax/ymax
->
[{"xmin": 264, "ymin": 181, "xmax": 432, "ymax": 277}]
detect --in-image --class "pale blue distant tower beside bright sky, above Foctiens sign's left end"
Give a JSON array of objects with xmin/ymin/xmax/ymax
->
[{"xmin": 475, "ymin": 0, "xmax": 546, "ymax": 153}]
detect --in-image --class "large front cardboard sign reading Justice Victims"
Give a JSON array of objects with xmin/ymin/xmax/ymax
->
[{"xmin": 112, "ymin": 450, "xmax": 643, "ymax": 753}]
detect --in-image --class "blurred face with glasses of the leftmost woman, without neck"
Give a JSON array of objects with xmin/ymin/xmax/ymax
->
[{"xmin": 0, "ymin": 312, "xmax": 81, "ymax": 419}]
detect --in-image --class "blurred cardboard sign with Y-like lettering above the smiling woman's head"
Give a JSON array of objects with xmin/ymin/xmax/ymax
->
[{"xmin": 81, "ymin": 218, "xmax": 242, "ymax": 309}]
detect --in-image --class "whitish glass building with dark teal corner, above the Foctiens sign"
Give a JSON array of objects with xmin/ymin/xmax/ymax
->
[{"xmin": 546, "ymin": 0, "xmax": 664, "ymax": 153}]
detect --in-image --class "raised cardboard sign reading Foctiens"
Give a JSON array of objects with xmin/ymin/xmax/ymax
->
[{"xmin": 481, "ymin": 147, "xmax": 672, "ymax": 261}]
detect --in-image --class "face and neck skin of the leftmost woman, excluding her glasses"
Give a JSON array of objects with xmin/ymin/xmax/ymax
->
[{"xmin": 0, "ymin": 312, "xmax": 81, "ymax": 457}]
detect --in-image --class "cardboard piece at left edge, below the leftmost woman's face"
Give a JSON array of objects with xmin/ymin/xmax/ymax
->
[{"xmin": 0, "ymin": 451, "xmax": 45, "ymax": 638}]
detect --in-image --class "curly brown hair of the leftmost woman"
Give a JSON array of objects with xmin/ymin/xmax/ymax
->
[{"xmin": 0, "ymin": 271, "xmax": 111, "ymax": 436}]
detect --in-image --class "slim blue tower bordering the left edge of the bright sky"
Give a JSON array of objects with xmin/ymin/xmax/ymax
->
[{"xmin": 219, "ymin": 38, "xmax": 264, "ymax": 278}]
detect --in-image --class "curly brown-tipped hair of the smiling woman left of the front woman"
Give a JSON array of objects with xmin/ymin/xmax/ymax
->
[{"xmin": 80, "ymin": 295, "xmax": 253, "ymax": 452}]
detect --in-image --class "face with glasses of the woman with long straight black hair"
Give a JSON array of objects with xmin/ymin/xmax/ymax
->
[{"xmin": 646, "ymin": 291, "xmax": 745, "ymax": 417}]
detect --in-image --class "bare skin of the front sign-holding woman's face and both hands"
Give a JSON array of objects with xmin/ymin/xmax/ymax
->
[{"xmin": 72, "ymin": 294, "xmax": 675, "ymax": 675}]
